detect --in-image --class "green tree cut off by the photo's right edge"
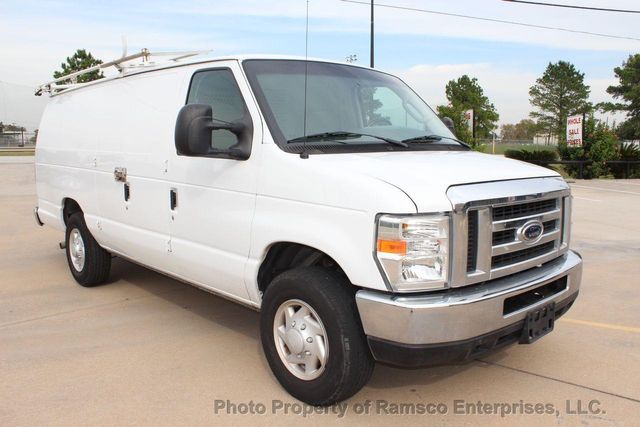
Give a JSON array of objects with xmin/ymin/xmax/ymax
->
[{"xmin": 600, "ymin": 54, "xmax": 640, "ymax": 139}]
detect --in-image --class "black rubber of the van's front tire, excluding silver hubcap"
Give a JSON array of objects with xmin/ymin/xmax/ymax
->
[{"xmin": 260, "ymin": 267, "xmax": 374, "ymax": 406}]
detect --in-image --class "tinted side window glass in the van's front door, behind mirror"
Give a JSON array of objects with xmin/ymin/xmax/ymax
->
[{"xmin": 187, "ymin": 69, "xmax": 248, "ymax": 150}]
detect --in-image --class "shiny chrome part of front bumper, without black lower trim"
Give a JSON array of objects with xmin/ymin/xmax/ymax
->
[{"xmin": 356, "ymin": 251, "xmax": 582, "ymax": 345}]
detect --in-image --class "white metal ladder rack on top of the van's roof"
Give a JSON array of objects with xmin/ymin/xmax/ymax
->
[{"xmin": 35, "ymin": 48, "xmax": 210, "ymax": 96}]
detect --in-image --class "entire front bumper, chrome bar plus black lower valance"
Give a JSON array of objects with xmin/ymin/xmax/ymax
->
[{"xmin": 356, "ymin": 251, "xmax": 582, "ymax": 367}]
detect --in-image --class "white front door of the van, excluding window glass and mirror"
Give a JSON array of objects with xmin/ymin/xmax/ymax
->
[{"xmin": 167, "ymin": 61, "xmax": 262, "ymax": 301}]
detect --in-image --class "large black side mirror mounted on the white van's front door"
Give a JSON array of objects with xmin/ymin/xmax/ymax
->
[{"xmin": 175, "ymin": 104, "xmax": 251, "ymax": 160}]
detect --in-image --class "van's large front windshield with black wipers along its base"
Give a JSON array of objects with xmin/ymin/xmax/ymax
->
[{"xmin": 243, "ymin": 60, "xmax": 466, "ymax": 152}]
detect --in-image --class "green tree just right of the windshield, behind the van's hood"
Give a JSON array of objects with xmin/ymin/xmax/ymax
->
[{"xmin": 437, "ymin": 74, "xmax": 500, "ymax": 146}]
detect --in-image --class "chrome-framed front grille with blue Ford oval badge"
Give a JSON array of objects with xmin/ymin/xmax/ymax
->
[{"xmin": 447, "ymin": 177, "xmax": 571, "ymax": 288}]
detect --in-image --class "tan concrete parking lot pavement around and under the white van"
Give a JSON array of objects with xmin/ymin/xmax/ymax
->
[{"xmin": 0, "ymin": 158, "xmax": 640, "ymax": 426}]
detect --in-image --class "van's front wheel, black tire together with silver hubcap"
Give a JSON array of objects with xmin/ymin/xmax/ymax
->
[{"xmin": 260, "ymin": 267, "xmax": 374, "ymax": 406}]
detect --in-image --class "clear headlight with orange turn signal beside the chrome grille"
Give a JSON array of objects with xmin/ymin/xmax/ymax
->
[{"xmin": 376, "ymin": 214, "xmax": 449, "ymax": 292}]
